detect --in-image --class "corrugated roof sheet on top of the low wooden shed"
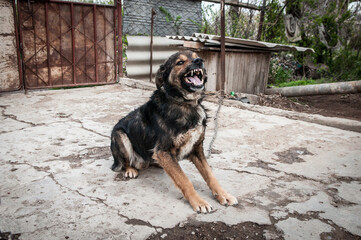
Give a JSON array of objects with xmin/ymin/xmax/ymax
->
[{"xmin": 167, "ymin": 33, "xmax": 315, "ymax": 52}]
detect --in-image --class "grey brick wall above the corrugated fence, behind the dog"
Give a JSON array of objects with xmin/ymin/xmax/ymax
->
[{"xmin": 123, "ymin": 0, "xmax": 202, "ymax": 36}]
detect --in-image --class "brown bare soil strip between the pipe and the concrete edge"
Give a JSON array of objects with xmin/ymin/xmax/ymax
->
[{"xmin": 258, "ymin": 93, "xmax": 361, "ymax": 121}]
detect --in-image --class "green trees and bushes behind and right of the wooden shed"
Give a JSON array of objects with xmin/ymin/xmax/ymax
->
[{"xmin": 200, "ymin": 0, "xmax": 361, "ymax": 86}]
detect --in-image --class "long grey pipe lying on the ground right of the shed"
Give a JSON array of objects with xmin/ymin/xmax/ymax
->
[{"xmin": 265, "ymin": 80, "xmax": 361, "ymax": 97}]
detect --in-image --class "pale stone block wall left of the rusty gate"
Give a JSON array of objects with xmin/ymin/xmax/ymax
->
[{"xmin": 0, "ymin": 0, "xmax": 20, "ymax": 91}]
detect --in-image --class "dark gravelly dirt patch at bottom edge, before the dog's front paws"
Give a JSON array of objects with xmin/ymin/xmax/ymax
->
[{"xmin": 148, "ymin": 222, "xmax": 283, "ymax": 240}]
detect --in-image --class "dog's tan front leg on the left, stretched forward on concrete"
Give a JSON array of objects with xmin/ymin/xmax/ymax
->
[{"xmin": 153, "ymin": 151, "xmax": 212, "ymax": 213}]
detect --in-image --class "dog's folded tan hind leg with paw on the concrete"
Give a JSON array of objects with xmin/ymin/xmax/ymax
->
[{"xmin": 110, "ymin": 130, "xmax": 138, "ymax": 178}]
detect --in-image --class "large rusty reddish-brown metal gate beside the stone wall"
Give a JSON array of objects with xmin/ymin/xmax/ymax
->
[{"xmin": 18, "ymin": 0, "xmax": 122, "ymax": 89}]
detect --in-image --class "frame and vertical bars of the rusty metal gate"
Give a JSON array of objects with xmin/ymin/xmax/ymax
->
[{"xmin": 13, "ymin": 0, "xmax": 123, "ymax": 90}]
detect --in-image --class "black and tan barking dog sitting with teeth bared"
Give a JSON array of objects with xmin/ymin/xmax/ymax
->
[{"xmin": 111, "ymin": 51, "xmax": 238, "ymax": 213}]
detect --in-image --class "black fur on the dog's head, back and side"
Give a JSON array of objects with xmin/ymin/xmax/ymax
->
[{"xmin": 111, "ymin": 51, "xmax": 206, "ymax": 170}]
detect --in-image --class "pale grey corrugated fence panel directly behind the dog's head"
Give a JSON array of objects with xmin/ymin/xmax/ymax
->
[{"xmin": 126, "ymin": 36, "xmax": 183, "ymax": 81}]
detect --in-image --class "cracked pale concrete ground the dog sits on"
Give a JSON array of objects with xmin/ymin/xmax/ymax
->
[{"xmin": 0, "ymin": 85, "xmax": 361, "ymax": 240}]
